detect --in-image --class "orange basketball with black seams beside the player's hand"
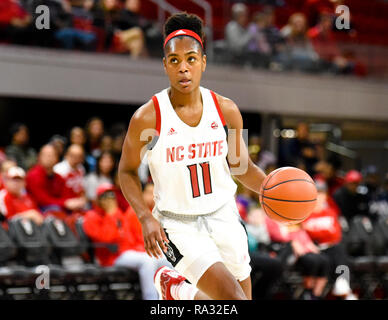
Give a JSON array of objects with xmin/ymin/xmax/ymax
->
[{"xmin": 260, "ymin": 167, "xmax": 317, "ymax": 224}]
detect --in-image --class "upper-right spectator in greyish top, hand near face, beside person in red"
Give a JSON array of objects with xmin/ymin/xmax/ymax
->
[{"xmin": 280, "ymin": 13, "xmax": 318, "ymax": 71}]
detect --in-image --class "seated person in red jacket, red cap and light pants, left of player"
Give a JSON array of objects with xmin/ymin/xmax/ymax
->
[{"xmin": 83, "ymin": 184, "xmax": 169, "ymax": 300}]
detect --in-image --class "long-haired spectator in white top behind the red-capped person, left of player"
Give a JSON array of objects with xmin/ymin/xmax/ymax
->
[{"xmin": 85, "ymin": 151, "xmax": 116, "ymax": 201}]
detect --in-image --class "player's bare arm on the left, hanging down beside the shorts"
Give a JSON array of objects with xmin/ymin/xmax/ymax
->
[{"xmin": 118, "ymin": 100, "xmax": 168, "ymax": 258}]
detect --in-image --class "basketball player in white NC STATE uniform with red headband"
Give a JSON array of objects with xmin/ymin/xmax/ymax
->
[{"xmin": 119, "ymin": 13, "xmax": 265, "ymax": 300}]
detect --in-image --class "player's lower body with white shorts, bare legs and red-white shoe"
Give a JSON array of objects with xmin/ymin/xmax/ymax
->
[{"xmin": 155, "ymin": 199, "xmax": 251, "ymax": 300}]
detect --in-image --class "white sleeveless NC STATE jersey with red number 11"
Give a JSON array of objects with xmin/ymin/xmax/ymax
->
[{"xmin": 147, "ymin": 87, "xmax": 237, "ymax": 215}]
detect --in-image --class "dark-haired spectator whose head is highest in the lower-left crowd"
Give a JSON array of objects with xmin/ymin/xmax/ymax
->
[{"xmin": 85, "ymin": 117, "xmax": 105, "ymax": 172}]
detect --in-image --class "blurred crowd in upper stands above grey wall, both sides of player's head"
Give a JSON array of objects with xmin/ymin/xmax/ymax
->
[{"xmin": 0, "ymin": 0, "xmax": 378, "ymax": 76}]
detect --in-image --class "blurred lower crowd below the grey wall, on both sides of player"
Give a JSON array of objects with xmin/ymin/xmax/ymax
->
[{"xmin": 0, "ymin": 117, "xmax": 388, "ymax": 300}]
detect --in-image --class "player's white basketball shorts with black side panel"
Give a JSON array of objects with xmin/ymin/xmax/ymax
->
[{"xmin": 153, "ymin": 198, "xmax": 251, "ymax": 285}]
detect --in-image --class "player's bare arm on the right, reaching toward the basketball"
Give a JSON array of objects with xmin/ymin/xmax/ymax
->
[{"xmin": 217, "ymin": 95, "xmax": 266, "ymax": 193}]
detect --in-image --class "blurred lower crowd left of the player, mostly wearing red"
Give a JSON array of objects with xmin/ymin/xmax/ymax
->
[{"xmin": 0, "ymin": 117, "xmax": 169, "ymax": 300}]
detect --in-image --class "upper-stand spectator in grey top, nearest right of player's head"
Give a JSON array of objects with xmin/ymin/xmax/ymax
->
[{"xmin": 225, "ymin": 3, "xmax": 253, "ymax": 64}]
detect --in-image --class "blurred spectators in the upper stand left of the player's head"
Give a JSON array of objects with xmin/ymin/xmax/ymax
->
[{"xmin": 0, "ymin": 0, "xmax": 162, "ymax": 58}]
